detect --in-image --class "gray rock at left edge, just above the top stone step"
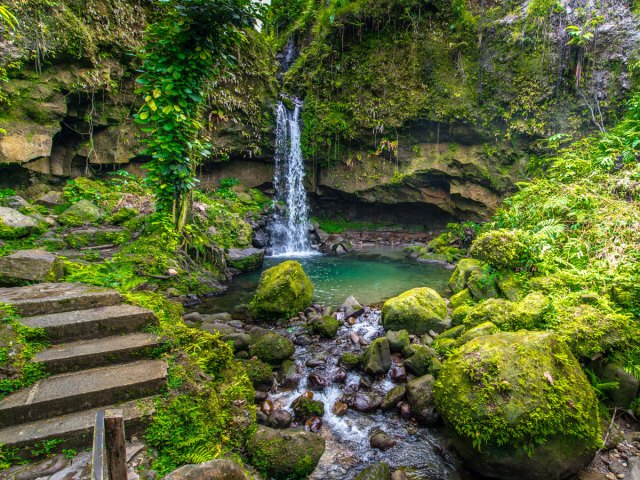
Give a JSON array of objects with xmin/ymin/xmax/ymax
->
[{"xmin": 0, "ymin": 250, "xmax": 64, "ymax": 286}]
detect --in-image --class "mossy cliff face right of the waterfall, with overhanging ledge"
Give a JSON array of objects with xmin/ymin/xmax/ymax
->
[{"xmin": 273, "ymin": 0, "xmax": 640, "ymax": 219}]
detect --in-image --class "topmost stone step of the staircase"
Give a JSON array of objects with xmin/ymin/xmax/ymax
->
[{"xmin": 0, "ymin": 283, "xmax": 122, "ymax": 316}]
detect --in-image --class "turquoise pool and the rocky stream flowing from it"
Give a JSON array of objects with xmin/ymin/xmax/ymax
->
[{"xmin": 198, "ymin": 248, "xmax": 480, "ymax": 480}]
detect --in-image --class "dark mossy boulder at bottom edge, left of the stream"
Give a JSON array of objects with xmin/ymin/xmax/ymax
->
[{"xmin": 247, "ymin": 427, "xmax": 325, "ymax": 480}]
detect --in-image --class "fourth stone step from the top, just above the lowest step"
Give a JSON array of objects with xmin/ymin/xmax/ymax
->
[{"xmin": 0, "ymin": 360, "xmax": 167, "ymax": 428}]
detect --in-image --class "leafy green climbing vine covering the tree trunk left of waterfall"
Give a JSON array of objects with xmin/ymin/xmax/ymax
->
[{"xmin": 135, "ymin": 0, "xmax": 261, "ymax": 231}]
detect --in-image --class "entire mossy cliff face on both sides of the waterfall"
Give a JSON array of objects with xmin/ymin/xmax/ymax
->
[{"xmin": 0, "ymin": 0, "xmax": 640, "ymax": 223}]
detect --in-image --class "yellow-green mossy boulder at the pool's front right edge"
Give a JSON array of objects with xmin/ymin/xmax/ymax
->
[{"xmin": 382, "ymin": 287, "xmax": 448, "ymax": 335}]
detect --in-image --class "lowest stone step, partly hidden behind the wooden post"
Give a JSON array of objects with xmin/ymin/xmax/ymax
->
[{"xmin": 0, "ymin": 397, "xmax": 155, "ymax": 455}]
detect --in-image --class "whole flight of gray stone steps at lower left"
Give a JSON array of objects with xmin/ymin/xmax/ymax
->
[{"xmin": 0, "ymin": 283, "xmax": 167, "ymax": 456}]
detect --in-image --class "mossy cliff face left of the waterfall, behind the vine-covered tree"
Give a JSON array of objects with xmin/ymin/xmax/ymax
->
[{"xmin": 0, "ymin": 0, "xmax": 275, "ymax": 184}]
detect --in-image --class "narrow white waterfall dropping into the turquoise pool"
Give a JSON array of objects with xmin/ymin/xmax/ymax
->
[{"xmin": 271, "ymin": 100, "xmax": 315, "ymax": 256}]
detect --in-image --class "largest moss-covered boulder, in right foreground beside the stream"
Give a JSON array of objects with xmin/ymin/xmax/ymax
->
[{"xmin": 435, "ymin": 331, "xmax": 600, "ymax": 480}]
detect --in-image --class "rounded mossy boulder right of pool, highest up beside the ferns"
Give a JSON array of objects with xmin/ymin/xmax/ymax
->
[{"xmin": 469, "ymin": 229, "xmax": 532, "ymax": 270}]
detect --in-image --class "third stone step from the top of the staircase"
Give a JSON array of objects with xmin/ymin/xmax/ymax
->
[{"xmin": 34, "ymin": 333, "xmax": 162, "ymax": 373}]
